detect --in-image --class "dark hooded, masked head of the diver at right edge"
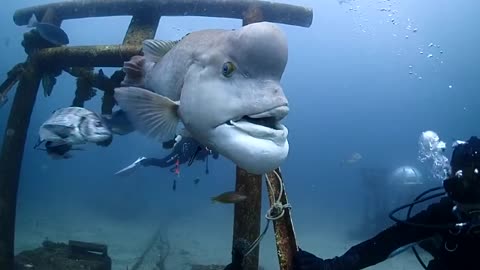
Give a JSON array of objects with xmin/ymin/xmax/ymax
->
[{"xmin": 443, "ymin": 137, "xmax": 480, "ymax": 205}]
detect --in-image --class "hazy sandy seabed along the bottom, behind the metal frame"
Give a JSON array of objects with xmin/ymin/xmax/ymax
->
[{"xmin": 15, "ymin": 202, "xmax": 428, "ymax": 270}]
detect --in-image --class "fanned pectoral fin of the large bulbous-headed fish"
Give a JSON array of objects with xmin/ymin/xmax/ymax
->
[{"xmin": 114, "ymin": 87, "xmax": 180, "ymax": 141}]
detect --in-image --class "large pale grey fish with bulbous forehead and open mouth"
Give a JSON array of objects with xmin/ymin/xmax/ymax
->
[{"xmin": 115, "ymin": 22, "xmax": 289, "ymax": 174}]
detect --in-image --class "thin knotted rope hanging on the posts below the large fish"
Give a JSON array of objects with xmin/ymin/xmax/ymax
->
[{"xmin": 244, "ymin": 171, "xmax": 292, "ymax": 257}]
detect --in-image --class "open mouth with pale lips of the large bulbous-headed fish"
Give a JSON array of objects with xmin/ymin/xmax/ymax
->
[{"xmin": 224, "ymin": 105, "xmax": 289, "ymax": 144}]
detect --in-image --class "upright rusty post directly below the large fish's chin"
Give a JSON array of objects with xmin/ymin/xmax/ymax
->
[{"xmin": 233, "ymin": 166, "xmax": 262, "ymax": 270}]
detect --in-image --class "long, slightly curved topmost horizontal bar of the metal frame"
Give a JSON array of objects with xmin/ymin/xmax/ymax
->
[{"xmin": 13, "ymin": 0, "xmax": 313, "ymax": 27}]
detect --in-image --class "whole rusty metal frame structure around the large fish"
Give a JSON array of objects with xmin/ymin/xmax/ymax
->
[{"xmin": 0, "ymin": 0, "xmax": 313, "ymax": 270}]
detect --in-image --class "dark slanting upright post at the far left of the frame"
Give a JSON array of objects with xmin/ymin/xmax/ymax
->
[{"xmin": 0, "ymin": 60, "xmax": 41, "ymax": 269}]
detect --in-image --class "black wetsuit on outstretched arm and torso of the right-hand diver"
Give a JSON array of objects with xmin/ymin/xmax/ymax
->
[{"xmin": 321, "ymin": 198, "xmax": 480, "ymax": 270}]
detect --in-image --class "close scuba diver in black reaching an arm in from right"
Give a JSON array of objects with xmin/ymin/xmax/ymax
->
[{"xmin": 293, "ymin": 137, "xmax": 480, "ymax": 270}]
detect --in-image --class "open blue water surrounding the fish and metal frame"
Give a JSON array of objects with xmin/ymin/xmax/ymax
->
[{"xmin": 0, "ymin": 0, "xmax": 480, "ymax": 269}]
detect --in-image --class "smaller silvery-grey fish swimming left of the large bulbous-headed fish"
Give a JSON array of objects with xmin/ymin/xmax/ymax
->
[{"xmin": 39, "ymin": 107, "xmax": 112, "ymax": 146}]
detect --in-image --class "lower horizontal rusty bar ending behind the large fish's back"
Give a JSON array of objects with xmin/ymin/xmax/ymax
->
[{"xmin": 34, "ymin": 45, "xmax": 142, "ymax": 67}]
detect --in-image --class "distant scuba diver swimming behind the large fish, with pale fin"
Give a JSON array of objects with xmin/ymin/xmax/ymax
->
[{"xmin": 115, "ymin": 137, "xmax": 219, "ymax": 175}]
